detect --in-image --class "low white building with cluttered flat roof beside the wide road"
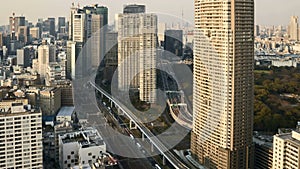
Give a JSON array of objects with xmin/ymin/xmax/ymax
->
[{"xmin": 59, "ymin": 128, "xmax": 106, "ymax": 169}]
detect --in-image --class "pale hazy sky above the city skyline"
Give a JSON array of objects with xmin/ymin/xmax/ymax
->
[{"xmin": 0, "ymin": 0, "xmax": 300, "ymax": 25}]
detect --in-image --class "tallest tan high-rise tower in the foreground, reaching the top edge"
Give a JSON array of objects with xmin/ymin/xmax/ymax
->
[{"xmin": 191, "ymin": 0, "xmax": 254, "ymax": 169}]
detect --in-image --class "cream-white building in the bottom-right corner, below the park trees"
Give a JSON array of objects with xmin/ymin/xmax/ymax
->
[{"xmin": 273, "ymin": 131, "xmax": 300, "ymax": 169}]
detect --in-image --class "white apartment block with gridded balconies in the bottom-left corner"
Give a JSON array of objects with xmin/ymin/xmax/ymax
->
[{"xmin": 0, "ymin": 103, "xmax": 43, "ymax": 169}]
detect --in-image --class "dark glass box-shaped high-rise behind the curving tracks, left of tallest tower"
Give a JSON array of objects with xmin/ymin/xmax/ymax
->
[{"xmin": 164, "ymin": 30, "xmax": 183, "ymax": 57}]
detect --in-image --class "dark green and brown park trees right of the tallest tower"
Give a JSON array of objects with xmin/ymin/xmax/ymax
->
[{"xmin": 254, "ymin": 67, "xmax": 300, "ymax": 132}]
